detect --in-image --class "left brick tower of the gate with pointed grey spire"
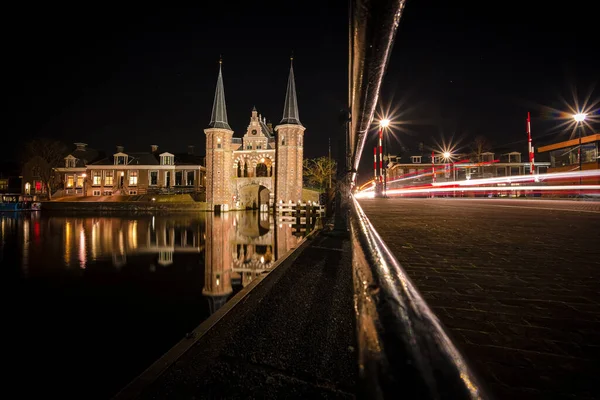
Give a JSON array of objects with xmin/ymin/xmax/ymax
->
[{"xmin": 204, "ymin": 61, "xmax": 233, "ymax": 211}]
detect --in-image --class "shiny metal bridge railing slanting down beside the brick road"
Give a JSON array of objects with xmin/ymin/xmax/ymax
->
[{"xmin": 349, "ymin": 196, "xmax": 489, "ymax": 399}]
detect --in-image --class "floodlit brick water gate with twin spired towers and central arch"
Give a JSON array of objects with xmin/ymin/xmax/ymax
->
[{"xmin": 204, "ymin": 59, "xmax": 305, "ymax": 211}]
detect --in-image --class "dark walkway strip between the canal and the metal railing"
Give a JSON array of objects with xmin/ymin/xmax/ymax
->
[{"xmin": 117, "ymin": 228, "xmax": 357, "ymax": 399}]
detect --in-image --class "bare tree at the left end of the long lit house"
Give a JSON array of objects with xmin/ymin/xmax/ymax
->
[{"xmin": 24, "ymin": 138, "xmax": 67, "ymax": 200}]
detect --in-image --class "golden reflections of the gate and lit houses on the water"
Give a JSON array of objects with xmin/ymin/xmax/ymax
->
[{"xmin": 43, "ymin": 211, "xmax": 302, "ymax": 314}]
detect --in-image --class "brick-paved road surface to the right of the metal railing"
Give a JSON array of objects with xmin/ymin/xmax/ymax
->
[{"xmin": 361, "ymin": 199, "xmax": 600, "ymax": 399}]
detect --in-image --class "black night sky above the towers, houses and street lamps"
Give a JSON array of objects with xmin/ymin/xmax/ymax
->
[{"xmin": 3, "ymin": 0, "xmax": 600, "ymax": 177}]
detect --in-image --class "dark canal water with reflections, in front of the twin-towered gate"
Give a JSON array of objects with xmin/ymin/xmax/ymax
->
[{"xmin": 0, "ymin": 212, "xmax": 301, "ymax": 399}]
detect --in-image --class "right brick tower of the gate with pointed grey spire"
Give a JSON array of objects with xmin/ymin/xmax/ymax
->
[{"xmin": 275, "ymin": 64, "xmax": 306, "ymax": 203}]
